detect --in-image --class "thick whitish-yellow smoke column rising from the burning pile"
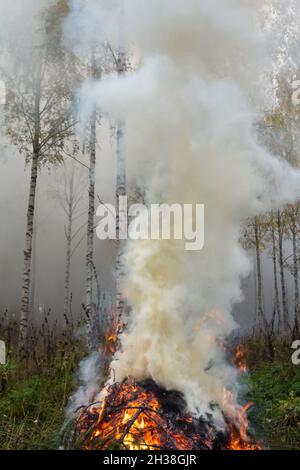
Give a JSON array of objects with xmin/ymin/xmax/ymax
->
[{"xmin": 69, "ymin": 0, "xmax": 300, "ymax": 422}]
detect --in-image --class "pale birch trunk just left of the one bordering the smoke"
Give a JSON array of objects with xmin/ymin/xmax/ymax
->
[{"xmin": 86, "ymin": 54, "xmax": 97, "ymax": 351}]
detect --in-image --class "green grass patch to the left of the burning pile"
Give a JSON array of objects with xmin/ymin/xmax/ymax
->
[{"xmin": 0, "ymin": 355, "xmax": 78, "ymax": 450}]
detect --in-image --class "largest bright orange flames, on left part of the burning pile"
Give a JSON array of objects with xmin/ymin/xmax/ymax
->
[{"xmin": 77, "ymin": 382, "xmax": 193, "ymax": 450}]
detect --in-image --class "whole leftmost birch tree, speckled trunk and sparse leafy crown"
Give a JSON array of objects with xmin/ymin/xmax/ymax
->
[{"xmin": 6, "ymin": 2, "xmax": 74, "ymax": 358}]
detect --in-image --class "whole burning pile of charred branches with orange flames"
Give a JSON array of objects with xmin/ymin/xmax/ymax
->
[{"xmin": 70, "ymin": 379, "xmax": 260, "ymax": 450}]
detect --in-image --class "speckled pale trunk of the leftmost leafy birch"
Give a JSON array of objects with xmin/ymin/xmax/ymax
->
[{"xmin": 19, "ymin": 59, "xmax": 42, "ymax": 359}]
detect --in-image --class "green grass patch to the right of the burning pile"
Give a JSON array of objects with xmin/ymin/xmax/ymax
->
[{"xmin": 249, "ymin": 360, "xmax": 300, "ymax": 449}]
